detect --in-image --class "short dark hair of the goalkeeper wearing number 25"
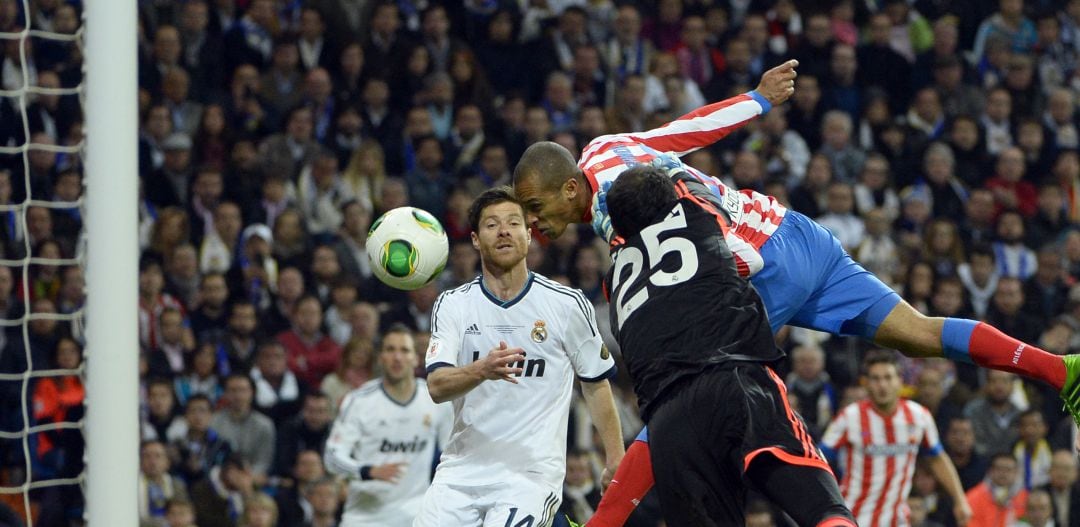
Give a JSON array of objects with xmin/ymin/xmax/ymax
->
[{"xmin": 607, "ymin": 165, "xmax": 678, "ymax": 238}]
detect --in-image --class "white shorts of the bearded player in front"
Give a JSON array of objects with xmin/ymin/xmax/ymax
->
[{"xmin": 413, "ymin": 479, "xmax": 563, "ymax": 527}]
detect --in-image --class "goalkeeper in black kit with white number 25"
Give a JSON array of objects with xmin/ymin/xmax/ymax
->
[{"xmin": 605, "ymin": 166, "xmax": 855, "ymax": 527}]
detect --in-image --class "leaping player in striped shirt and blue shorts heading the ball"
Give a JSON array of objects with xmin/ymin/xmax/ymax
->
[{"xmin": 514, "ymin": 60, "xmax": 1080, "ymax": 526}]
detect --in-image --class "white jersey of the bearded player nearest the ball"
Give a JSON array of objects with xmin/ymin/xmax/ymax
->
[{"xmin": 427, "ymin": 273, "xmax": 615, "ymax": 489}]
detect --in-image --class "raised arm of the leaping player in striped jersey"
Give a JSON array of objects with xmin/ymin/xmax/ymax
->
[{"xmin": 600, "ymin": 59, "xmax": 799, "ymax": 156}]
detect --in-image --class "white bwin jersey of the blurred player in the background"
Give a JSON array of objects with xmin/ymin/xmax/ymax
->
[{"xmin": 325, "ymin": 379, "xmax": 454, "ymax": 527}]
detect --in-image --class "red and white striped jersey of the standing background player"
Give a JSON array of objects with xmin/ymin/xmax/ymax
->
[{"xmin": 822, "ymin": 398, "xmax": 942, "ymax": 527}]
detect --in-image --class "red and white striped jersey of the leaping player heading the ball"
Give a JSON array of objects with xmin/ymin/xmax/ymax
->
[{"xmin": 578, "ymin": 94, "xmax": 787, "ymax": 276}]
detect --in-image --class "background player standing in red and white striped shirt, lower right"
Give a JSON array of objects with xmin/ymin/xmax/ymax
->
[{"xmin": 821, "ymin": 350, "xmax": 972, "ymax": 527}]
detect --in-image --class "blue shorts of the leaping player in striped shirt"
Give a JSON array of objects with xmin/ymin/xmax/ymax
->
[{"xmin": 751, "ymin": 211, "xmax": 900, "ymax": 339}]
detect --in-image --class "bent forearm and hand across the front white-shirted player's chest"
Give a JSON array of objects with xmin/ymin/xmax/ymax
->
[{"xmin": 428, "ymin": 342, "xmax": 525, "ymax": 403}]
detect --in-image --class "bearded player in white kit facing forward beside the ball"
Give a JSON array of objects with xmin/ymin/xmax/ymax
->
[{"xmin": 414, "ymin": 187, "xmax": 623, "ymax": 527}]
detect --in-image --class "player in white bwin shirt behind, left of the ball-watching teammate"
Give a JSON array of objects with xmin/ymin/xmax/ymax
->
[{"xmin": 326, "ymin": 326, "xmax": 454, "ymax": 527}]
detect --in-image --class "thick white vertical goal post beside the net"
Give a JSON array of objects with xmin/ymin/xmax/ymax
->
[{"xmin": 83, "ymin": 0, "xmax": 139, "ymax": 527}]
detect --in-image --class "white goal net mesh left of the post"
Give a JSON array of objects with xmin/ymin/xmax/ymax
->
[{"xmin": 0, "ymin": 0, "xmax": 85, "ymax": 526}]
